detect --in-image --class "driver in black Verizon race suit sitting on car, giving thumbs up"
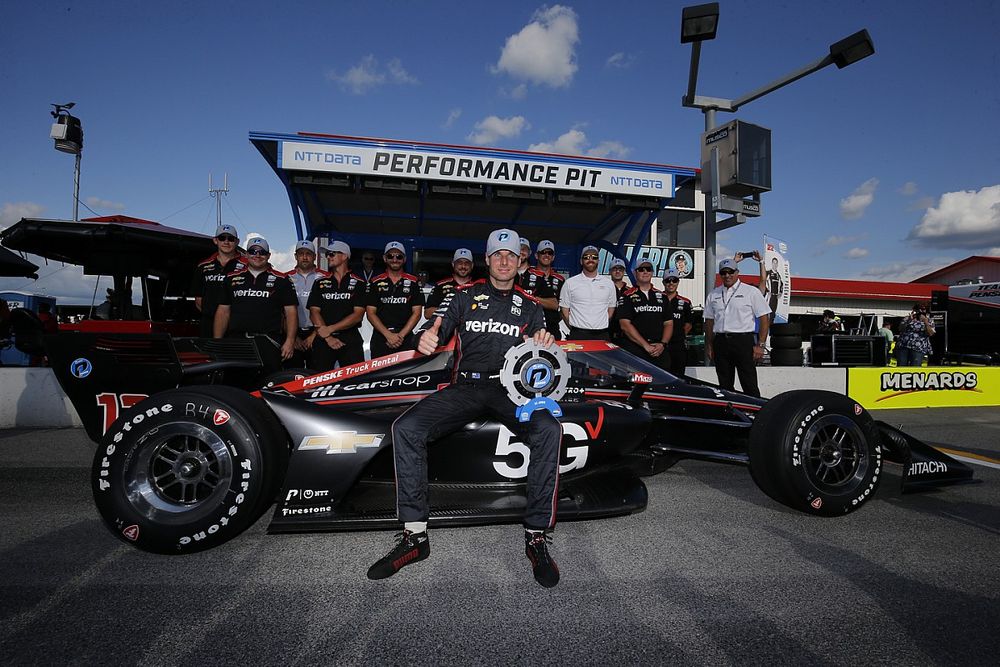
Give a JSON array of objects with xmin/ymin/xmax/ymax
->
[{"xmin": 368, "ymin": 229, "xmax": 562, "ymax": 588}]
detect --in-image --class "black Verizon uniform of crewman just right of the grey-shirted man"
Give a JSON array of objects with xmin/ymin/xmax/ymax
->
[{"xmin": 306, "ymin": 273, "xmax": 368, "ymax": 371}]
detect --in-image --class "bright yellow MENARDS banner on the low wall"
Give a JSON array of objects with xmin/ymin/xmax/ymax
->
[{"xmin": 847, "ymin": 366, "xmax": 1000, "ymax": 409}]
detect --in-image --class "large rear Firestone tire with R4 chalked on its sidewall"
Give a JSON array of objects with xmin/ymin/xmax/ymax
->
[{"xmin": 91, "ymin": 385, "xmax": 288, "ymax": 554}]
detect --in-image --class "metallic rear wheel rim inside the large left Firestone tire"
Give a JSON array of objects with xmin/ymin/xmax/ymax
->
[{"xmin": 123, "ymin": 422, "xmax": 233, "ymax": 524}]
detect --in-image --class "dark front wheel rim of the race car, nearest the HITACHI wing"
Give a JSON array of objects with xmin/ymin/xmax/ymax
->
[{"xmin": 802, "ymin": 415, "xmax": 868, "ymax": 494}]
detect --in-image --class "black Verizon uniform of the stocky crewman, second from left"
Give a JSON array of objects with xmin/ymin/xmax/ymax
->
[{"xmin": 219, "ymin": 269, "xmax": 299, "ymax": 373}]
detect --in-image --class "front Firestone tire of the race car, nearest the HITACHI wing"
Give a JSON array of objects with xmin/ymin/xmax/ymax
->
[{"xmin": 749, "ymin": 390, "xmax": 882, "ymax": 516}]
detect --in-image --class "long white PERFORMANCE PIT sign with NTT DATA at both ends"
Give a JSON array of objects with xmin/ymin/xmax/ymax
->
[{"xmin": 278, "ymin": 141, "xmax": 674, "ymax": 198}]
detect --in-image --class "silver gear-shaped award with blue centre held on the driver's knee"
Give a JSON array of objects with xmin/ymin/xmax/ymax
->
[{"xmin": 500, "ymin": 340, "xmax": 570, "ymax": 422}]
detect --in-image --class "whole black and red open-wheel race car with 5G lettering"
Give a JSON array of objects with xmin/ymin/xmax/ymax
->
[{"xmin": 41, "ymin": 333, "xmax": 972, "ymax": 554}]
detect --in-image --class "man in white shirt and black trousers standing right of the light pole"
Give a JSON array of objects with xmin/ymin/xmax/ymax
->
[{"xmin": 705, "ymin": 259, "xmax": 771, "ymax": 396}]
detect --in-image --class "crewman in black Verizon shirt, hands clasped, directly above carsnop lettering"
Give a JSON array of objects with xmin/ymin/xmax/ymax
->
[{"xmin": 367, "ymin": 241, "xmax": 424, "ymax": 359}]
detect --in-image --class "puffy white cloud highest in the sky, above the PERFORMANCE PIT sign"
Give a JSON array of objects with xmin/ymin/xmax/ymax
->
[{"xmin": 492, "ymin": 5, "xmax": 580, "ymax": 88}]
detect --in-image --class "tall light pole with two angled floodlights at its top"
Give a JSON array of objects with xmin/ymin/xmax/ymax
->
[{"xmin": 681, "ymin": 2, "xmax": 875, "ymax": 348}]
